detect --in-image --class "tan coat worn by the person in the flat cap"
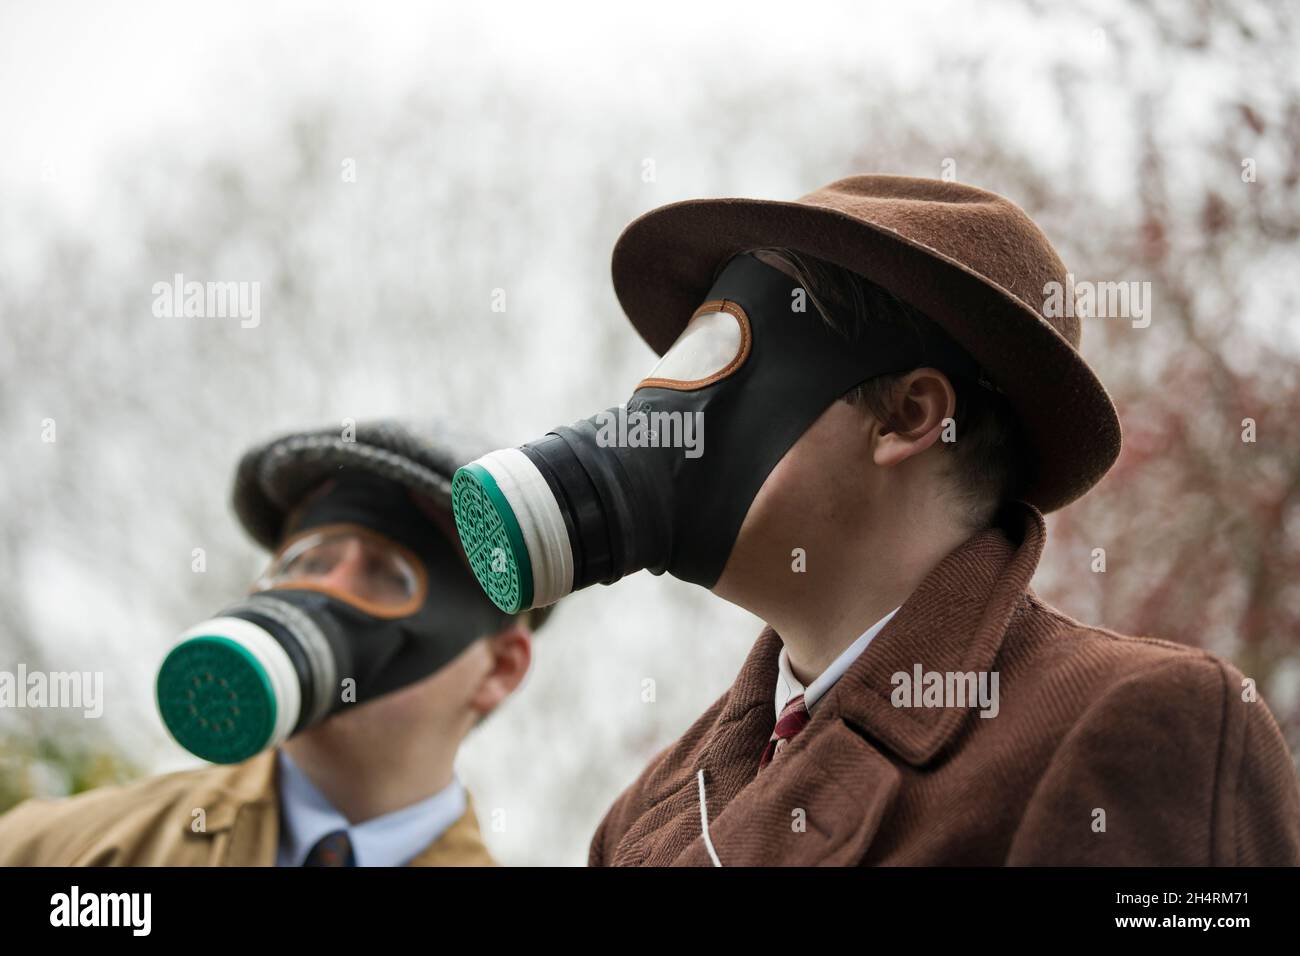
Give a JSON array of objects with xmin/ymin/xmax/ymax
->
[{"xmin": 0, "ymin": 750, "xmax": 495, "ymax": 866}]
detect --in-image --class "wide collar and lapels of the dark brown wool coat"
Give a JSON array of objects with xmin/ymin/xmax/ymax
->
[{"xmin": 673, "ymin": 502, "xmax": 1045, "ymax": 866}]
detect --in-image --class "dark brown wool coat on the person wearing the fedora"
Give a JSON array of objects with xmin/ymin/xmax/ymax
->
[{"xmin": 590, "ymin": 505, "xmax": 1300, "ymax": 866}]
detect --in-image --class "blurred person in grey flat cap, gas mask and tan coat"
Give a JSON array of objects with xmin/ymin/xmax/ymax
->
[{"xmin": 0, "ymin": 421, "xmax": 546, "ymax": 866}]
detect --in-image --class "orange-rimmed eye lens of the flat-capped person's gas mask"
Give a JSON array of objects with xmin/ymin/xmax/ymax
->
[{"xmin": 257, "ymin": 528, "xmax": 420, "ymax": 609}]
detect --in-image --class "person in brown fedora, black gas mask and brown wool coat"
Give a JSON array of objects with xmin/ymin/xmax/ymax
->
[{"xmin": 452, "ymin": 176, "xmax": 1300, "ymax": 866}]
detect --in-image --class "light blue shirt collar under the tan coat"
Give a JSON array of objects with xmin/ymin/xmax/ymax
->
[{"xmin": 276, "ymin": 749, "xmax": 468, "ymax": 866}]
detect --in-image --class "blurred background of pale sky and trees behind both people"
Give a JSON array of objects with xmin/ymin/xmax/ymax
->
[{"xmin": 0, "ymin": 1, "xmax": 1300, "ymax": 864}]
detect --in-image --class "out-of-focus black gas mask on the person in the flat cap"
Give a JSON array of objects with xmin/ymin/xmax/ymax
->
[{"xmin": 157, "ymin": 473, "xmax": 508, "ymax": 763}]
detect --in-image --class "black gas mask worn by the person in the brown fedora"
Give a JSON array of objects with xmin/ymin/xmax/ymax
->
[{"xmin": 452, "ymin": 255, "xmax": 979, "ymax": 611}]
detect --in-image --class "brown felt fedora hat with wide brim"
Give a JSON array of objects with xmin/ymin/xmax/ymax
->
[{"xmin": 612, "ymin": 176, "xmax": 1121, "ymax": 511}]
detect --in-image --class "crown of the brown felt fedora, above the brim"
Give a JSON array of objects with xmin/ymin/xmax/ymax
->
[{"xmin": 798, "ymin": 176, "xmax": 1080, "ymax": 349}]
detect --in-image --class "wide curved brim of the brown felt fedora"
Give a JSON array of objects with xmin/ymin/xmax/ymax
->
[{"xmin": 611, "ymin": 199, "xmax": 1122, "ymax": 512}]
